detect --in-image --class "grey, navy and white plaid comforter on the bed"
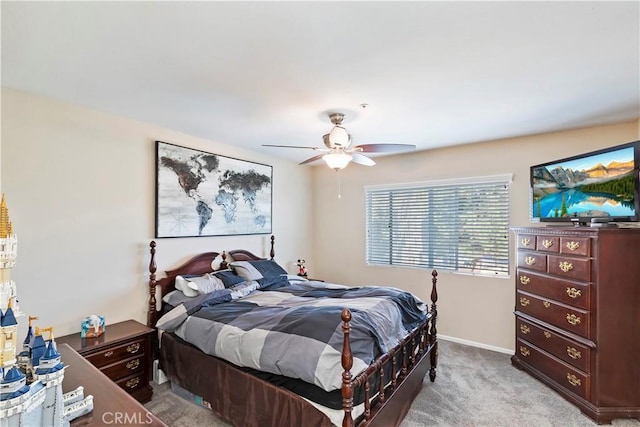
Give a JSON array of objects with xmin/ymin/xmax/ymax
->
[{"xmin": 157, "ymin": 281, "xmax": 427, "ymax": 391}]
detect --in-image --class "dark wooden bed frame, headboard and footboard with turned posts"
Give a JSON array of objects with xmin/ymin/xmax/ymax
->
[{"xmin": 147, "ymin": 236, "xmax": 438, "ymax": 427}]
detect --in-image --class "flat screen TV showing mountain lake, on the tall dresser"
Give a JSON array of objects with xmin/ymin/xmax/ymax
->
[{"xmin": 530, "ymin": 141, "xmax": 640, "ymax": 224}]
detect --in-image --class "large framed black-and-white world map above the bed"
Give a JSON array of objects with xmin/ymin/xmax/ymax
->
[{"xmin": 156, "ymin": 141, "xmax": 273, "ymax": 237}]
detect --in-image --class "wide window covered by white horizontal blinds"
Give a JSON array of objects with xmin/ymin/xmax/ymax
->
[{"xmin": 365, "ymin": 175, "xmax": 511, "ymax": 276}]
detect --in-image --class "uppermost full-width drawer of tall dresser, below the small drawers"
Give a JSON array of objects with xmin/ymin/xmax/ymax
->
[{"xmin": 516, "ymin": 269, "xmax": 591, "ymax": 310}]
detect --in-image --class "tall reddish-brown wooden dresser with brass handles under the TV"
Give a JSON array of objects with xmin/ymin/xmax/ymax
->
[{"xmin": 511, "ymin": 226, "xmax": 640, "ymax": 423}]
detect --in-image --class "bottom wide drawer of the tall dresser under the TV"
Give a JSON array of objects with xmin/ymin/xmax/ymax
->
[{"xmin": 516, "ymin": 338, "xmax": 591, "ymax": 399}]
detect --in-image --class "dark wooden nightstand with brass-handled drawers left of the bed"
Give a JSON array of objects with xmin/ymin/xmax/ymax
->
[{"xmin": 56, "ymin": 320, "xmax": 154, "ymax": 403}]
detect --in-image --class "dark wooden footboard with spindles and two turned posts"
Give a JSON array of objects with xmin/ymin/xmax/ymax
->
[{"xmin": 342, "ymin": 270, "xmax": 438, "ymax": 427}]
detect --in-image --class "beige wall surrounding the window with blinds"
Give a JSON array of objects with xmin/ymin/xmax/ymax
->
[{"xmin": 312, "ymin": 120, "xmax": 638, "ymax": 350}]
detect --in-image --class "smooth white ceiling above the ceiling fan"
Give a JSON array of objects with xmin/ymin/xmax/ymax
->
[{"xmin": 1, "ymin": 1, "xmax": 640, "ymax": 161}]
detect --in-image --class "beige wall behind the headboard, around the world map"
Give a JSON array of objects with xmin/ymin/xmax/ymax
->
[{"xmin": 1, "ymin": 88, "xmax": 314, "ymax": 335}]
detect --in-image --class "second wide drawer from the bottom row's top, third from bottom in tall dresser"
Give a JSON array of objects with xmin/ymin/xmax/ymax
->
[{"xmin": 516, "ymin": 291, "xmax": 591, "ymax": 338}]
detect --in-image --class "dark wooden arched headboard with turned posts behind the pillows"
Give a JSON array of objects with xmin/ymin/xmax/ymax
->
[{"xmin": 147, "ymin": 236, "xmax": 275, "ymax": 327}]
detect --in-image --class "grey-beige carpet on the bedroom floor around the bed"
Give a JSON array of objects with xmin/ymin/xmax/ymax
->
[{"xmin": 146, "ymin": 340, "xmax": 640, "ymax": 427}]
